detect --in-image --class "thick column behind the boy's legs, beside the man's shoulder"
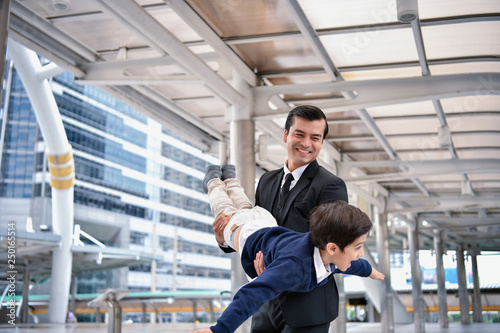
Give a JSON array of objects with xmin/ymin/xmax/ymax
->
[{"xmin": 230, "ymin": 71, "xmax": 255, "ymax": 333}]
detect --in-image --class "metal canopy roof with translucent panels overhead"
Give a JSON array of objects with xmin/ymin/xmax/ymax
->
[{"xmin": 9, "ymin": 0, "xmax": 500, "ymax": 250}]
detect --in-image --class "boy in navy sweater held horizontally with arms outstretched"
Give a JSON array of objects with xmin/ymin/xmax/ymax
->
[{"xmin": 195, "ymin": 165, "xmax": 384, "ymax": 333}]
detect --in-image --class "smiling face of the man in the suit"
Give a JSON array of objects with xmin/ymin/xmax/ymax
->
[{"xmin": 283, "ymin": 117, "xmax": 325, "ymax": 171}]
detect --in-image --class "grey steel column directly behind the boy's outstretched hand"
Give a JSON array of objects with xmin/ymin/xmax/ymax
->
[{"xmin": 376, "ymin": 213, "xmax": 394, "ymax": 333}]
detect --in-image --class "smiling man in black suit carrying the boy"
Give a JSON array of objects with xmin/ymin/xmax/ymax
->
[{"xmin": 214, "ymin": 105, "xmax": 348, "ymax": 333}]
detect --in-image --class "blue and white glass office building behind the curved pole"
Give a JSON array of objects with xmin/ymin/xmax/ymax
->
[{"xmin": 0, "ymin": 61, "xmax": 231, "ymax": 308}]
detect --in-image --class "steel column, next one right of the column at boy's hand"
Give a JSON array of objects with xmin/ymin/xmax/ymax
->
[{"xmin": 408, "ymin": 219, "xmax": 425, "ymax": 333}]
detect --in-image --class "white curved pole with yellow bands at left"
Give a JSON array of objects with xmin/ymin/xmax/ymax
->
[{"xmin": 7, "ymin": 39, "xmax": 74, "ymax": 323}]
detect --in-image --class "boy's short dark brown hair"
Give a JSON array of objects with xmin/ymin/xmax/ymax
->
[{"xmin": 309, "ymin": 200, "xmax": 373, "ymax": 252}]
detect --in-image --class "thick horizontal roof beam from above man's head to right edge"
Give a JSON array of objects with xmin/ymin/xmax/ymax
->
[{"xmin": 253, "ymin": 73, "xmax": 500, "ymax": 118}]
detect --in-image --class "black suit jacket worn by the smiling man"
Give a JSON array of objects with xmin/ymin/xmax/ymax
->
[{"xmin": 255, "ymin": 161, "xmax": 348, "ymax": 327}]
